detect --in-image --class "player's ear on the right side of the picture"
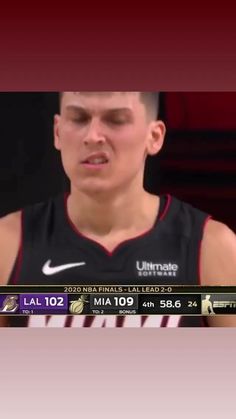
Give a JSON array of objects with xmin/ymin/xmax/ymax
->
[{"xmin": 147, "ymin": 120, "xmax": 166, "ymax": 156}]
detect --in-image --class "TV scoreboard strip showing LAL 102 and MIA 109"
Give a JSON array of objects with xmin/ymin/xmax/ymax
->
[{"xmin": 0, "ymin": 285, "xmax": 236, "ymax": 316}]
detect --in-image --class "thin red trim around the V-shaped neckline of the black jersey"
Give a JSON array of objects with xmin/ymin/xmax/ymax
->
[{"xmin": 64, "ymin": 192, "xmax": 171, "ymax": 257}]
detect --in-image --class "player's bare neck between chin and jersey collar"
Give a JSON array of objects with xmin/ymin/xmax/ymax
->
[{"xmin": 67, "ymin": 184, "xmax": 159, "ymax": 236}]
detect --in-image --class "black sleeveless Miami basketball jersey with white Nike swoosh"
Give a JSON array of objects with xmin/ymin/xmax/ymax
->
[{"xmin": 9, "ymin": 195, "xmax": 208, "ymax": 327}]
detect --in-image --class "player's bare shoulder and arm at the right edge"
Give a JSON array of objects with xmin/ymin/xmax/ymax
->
[{"xmin": 201, "ymin": 220, "xmax": 236, "ymax": 327}]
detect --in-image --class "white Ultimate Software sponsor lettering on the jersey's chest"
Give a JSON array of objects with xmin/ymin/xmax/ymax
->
[{"xmin": 136, "ymin": 260, "xmax": 179, "ymax": 278}]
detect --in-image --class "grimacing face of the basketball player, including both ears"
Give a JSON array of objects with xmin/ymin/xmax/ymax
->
[{"xmin": 54, "ymin": 92, "xmax": 165, "ymax": 194}]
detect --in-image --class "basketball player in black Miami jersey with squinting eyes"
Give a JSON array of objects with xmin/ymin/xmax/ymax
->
[{"xmin": 0, "ymin": 92, "xmax": 236, "ymax": 327}]
